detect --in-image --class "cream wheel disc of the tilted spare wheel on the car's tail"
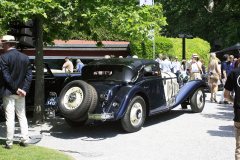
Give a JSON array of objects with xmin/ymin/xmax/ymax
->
[{"xmin": 64, "ymin": 87, "xmax": 83, "ymax": 110}]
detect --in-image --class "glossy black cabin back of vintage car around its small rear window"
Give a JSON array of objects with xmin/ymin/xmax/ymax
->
[{"xmin": 82, "ymin": 65, "xmax": 137, "ymax": 82}]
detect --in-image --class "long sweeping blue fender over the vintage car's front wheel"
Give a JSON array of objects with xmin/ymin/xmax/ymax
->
[{"xmin": 170, "ymin": 80, "xmax": 207, "ymax": 108}]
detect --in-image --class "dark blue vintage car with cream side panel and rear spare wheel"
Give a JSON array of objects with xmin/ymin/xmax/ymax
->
[{"xmin": 58, "ymin": 58, "xmax": 207, "ymax": 132}]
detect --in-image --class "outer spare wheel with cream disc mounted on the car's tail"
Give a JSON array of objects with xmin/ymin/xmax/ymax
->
[{"xmin": 58, "ymin": 80, "xmax": 92, "ymax": 120}]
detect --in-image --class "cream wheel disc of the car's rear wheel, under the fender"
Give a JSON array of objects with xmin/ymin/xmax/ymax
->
[{"xmin": 130, "ymin": 102, "xmax": 143, "ymax": 126}]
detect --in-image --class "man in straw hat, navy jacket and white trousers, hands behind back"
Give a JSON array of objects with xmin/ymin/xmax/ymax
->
[{"xmin": 0, "ymin": 35, "xmax": 32, "ymax": 149}]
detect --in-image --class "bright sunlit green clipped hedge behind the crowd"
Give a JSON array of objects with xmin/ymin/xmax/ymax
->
[{"xmin": 129, "ymin": 37, "xmax": 210, "ymax": 65}]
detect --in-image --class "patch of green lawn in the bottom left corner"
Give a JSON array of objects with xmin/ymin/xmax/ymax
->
[{"xmin": 0, "ymin": 140, "xmax": 74, "ymax": 160}]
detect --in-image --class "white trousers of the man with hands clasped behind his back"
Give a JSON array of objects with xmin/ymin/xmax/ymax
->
[{"xmin": 3, "ymin": 95, "xmax": 28, "ymax": 145}]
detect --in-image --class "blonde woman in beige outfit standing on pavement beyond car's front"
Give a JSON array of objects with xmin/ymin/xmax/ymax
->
[{"xmin": 207, "ymin": 53, "xmax": 221, "ymax": 102}]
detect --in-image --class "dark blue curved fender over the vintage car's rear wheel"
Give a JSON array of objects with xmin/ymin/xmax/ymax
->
[{"xmin": 107, "ymin": 85, "xmax": 149, "ymax": 120}]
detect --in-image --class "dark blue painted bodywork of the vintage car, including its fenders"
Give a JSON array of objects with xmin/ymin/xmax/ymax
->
[{"xmin": 89, "ymin": 76, "xmax": 207, "ymax": 121}]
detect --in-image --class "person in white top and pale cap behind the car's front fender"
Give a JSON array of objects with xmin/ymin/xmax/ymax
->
[{"xmin": 189, "ymin": 54, "xmax": 202, "ymax": 80}]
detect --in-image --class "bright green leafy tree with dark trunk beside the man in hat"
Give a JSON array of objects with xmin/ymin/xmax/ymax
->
[{"xmin": 0, "ymin": 0, "xmax": 166, "ymax": 123}]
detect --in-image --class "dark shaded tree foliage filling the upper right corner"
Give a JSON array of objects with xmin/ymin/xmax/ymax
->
[{"xmin": 159, "ymin": 0, "xmax": 240, "ymax": 50}]
